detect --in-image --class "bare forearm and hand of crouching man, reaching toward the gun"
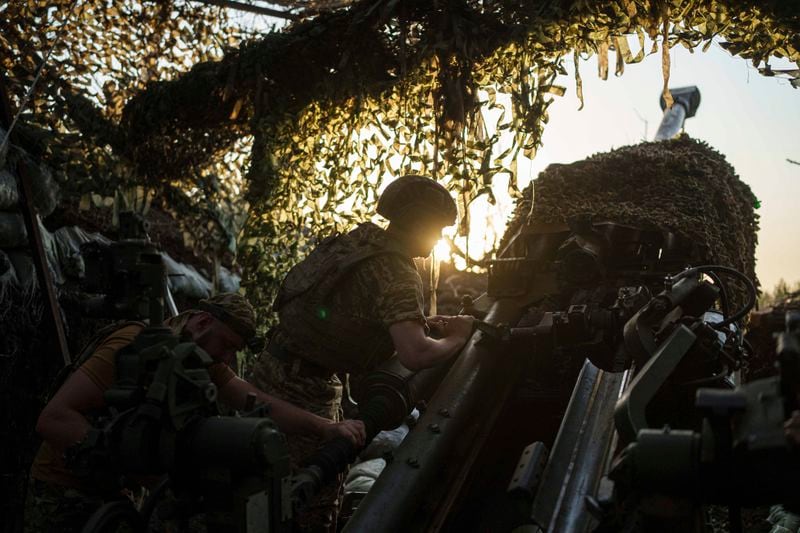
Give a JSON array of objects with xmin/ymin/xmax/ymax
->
[{"xmin": 219, "ymin": 377, "xmax": 366, "ymax": 446}]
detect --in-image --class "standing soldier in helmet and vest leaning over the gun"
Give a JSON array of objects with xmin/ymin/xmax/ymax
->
[{"xmin": 255, "ymin": 176, "xmax": 473, "ymax": 531}]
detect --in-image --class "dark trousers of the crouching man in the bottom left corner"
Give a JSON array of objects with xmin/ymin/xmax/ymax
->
[{"xmin": 24, "ymin": 479, "xmax": 104, "ymax": 533}]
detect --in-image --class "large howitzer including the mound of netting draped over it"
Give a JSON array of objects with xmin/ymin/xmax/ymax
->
[{"xmin": 338, "ymin": 90, "xmax": 768, "ymax": 532}]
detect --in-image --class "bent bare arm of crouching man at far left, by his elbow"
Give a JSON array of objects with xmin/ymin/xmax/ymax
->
[{"xmin": 36, "ymin": 369, "xmax": 104, "ymax": 450}]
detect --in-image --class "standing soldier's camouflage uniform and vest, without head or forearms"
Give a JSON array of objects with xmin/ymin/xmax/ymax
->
[{"xmin": 254, "ymin": 219, "xmax": 425, "ymax": 531}]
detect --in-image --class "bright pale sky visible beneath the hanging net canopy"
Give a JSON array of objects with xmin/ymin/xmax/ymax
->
[{"xmin": 239, "ymin": 15, "xmax": 800, "ymax": 290}]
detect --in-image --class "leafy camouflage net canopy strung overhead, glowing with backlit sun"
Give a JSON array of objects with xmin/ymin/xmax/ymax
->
[{"xmin": 0, "ymin": 0, "xmax": 800, "ymax": 316}]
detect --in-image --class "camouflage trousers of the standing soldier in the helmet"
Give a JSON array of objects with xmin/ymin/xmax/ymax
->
[{"xmin": 253, "ymin": 352, "xmax": 344, "ymax": 533}]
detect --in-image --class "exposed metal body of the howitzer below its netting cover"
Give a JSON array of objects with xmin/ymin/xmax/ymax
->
[{"xmin": 346, "ymin": 214, "xmax": 756, "ymax": 531}]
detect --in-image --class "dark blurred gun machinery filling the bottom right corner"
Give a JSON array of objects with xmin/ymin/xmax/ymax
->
[{"xmin": 595, "ymin": 312, "xmax": 800, "ymax": 532}]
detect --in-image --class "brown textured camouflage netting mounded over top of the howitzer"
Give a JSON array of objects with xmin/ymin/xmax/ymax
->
[{"xmin": 500, "ymin": 135, "xmax": 758, "ymax": 302}]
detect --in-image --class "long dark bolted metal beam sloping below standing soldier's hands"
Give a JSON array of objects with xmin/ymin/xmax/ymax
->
[{"xmin": 345, "ymin": 300, "xmax": 522, "ymax": 533}]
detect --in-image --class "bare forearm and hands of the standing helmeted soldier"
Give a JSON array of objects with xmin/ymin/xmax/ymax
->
[{"xmin": 389, "ymin": 315, "xmax": 475, "ymax": 370}]
